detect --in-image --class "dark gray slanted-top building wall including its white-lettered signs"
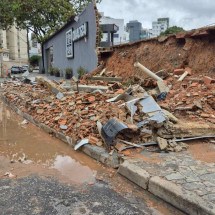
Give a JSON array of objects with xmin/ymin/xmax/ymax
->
[{"xmin": 42, "ymin": 3, "xmax": 98, "ymax": 75}]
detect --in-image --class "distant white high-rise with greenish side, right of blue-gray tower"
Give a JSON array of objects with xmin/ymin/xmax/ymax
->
[{"xmin": 150, "ymin": 18, "xmax": 169, "ymax": 37}]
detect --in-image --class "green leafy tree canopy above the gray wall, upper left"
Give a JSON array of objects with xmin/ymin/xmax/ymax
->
[{"xmin": 0, "ymin": 0, "xmax": 101, "ymax": 42}]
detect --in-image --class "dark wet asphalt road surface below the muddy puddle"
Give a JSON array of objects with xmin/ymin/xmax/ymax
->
[{"xmin": 0, "ymin": 176, "xmax": 153, "ymax": 215}]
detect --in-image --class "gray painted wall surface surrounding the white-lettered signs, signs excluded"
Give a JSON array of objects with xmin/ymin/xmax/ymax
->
[{"xmin": 43, "ymin": 3, "xmax": 98, "ymax": 75}]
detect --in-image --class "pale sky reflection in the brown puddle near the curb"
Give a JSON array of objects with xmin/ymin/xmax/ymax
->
[{"xmin": 52, "ymin": 155, "xmax": 96, "ymax": 183}]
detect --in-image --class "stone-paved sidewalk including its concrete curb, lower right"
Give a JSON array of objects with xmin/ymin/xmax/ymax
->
[{"xmin": 119, "ymin": 143, "xmax": 215, "ymax": 215}]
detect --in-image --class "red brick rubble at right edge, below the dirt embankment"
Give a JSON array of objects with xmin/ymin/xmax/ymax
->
[{"xmin": 159, "ymin": 75, "xmax": 215, "ymax": 124}]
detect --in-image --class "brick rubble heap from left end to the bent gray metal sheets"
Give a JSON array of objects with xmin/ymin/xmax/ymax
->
[{"xmin": 4, "ymin": 75, "xmax": 180, "ymax": 153}]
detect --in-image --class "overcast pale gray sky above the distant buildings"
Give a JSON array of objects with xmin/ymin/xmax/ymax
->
[{"xmin": 98, "ymin": 0, "xmax": 215, "ymax": 30}]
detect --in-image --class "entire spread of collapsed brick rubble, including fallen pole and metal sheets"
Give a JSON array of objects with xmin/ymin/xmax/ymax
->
[{"xmin": 3, "ymin": 59, "xmax": 215, "ymax": 153}]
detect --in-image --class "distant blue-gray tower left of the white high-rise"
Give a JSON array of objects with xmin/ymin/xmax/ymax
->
[{"xmin": 126, "ymin": 20, "xmax": 142, "ymax": 42}]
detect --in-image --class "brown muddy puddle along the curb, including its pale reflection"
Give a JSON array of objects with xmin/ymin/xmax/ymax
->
[{"xmin": 0, "ymin": 102, "xmax": 99, "ymax": 183}]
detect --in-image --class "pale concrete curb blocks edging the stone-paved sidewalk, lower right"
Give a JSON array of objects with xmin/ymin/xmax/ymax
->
[{"xmin": 118, "ymin": 161, "xmax": 215, "ymax": 215}]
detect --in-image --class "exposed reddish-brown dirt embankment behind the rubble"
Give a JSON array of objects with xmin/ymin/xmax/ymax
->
[{"xmin": 103, "ymin": 28, "xmax": 215, "ymax": 79}]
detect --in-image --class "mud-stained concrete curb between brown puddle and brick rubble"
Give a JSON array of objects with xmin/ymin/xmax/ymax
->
[{"xmin": 2, "ymin": 96, "xmax": 120, "ymax": 168}]
